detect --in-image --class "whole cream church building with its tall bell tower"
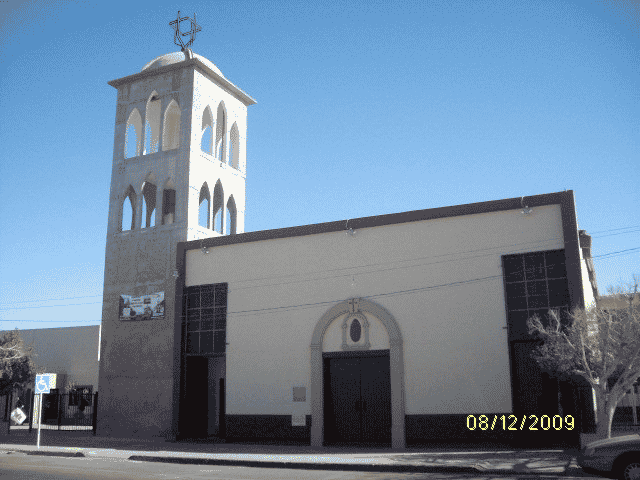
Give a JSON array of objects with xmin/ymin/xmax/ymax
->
[{"xmin": 97, "ymin": 31, "xmax": 597, "ymax": 449}]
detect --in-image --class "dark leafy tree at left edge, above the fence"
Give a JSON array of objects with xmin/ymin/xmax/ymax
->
[{"xmin": 0, "ymin": 328, "xmax": 36, "ymax": 395}]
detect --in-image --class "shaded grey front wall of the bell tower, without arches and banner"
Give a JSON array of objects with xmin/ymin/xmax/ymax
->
[{"xmin": 98, "ymin": 63, "xmax": 193, "ymax": 437}]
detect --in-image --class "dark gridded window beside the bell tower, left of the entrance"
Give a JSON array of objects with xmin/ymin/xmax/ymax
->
[{"xmin": 182, "ymin": 283, "xmax": 228, "ymax": 355}]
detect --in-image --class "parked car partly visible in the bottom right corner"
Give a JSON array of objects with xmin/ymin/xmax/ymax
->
[{"xmin": 578, "ymin": 435, "xmax": 640, "ymax": 480}]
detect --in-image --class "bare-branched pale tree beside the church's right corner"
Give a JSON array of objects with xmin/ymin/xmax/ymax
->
[{"xmin": 527, "ymin": 276, "xmax": 640, "ymax": 438}]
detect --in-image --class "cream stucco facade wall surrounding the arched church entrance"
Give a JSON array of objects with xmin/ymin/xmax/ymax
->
[{"xmin": 186, "ymin": 205, "xmax": 564, "ymax": 414}]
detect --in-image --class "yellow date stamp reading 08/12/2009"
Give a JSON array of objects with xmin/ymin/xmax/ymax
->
[{"xmin": 467, "ymin": 415, "xmax": 575, "ymax": 431}]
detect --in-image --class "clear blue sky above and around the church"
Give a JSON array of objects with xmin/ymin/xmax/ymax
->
[{"xmin": 0, "ymin": 0, "xmax": 640, "ymax": 330}]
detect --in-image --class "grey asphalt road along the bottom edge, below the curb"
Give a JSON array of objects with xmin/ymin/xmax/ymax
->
[{"xmin": 0, "ymin": 453, "xmax": 603, "ymax": 480}]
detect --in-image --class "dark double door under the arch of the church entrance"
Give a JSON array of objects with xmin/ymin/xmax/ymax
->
[{"xmin": 323, "ymin": 350, "xmax": 391, "ymax": 445}]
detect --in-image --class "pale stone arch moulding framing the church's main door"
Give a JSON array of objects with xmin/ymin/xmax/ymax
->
[{"xmin": 310, "ymin": 298, "xmax": 406, "ymax": 449}]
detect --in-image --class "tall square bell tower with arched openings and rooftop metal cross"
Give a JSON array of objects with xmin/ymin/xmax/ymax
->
[{"xmin": 98, "ymin": 13, "xmax": 256, "ymax": 437}]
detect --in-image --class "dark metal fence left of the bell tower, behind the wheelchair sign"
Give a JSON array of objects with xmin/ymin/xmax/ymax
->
[{"xmin": 0, "ymin": 391, "xmax": 98, "ymax": 435}]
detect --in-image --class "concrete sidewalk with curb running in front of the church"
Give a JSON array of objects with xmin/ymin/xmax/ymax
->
[{"xmin": 0, "ymin": 431, "xmax": 583, "ymax": 476}]
